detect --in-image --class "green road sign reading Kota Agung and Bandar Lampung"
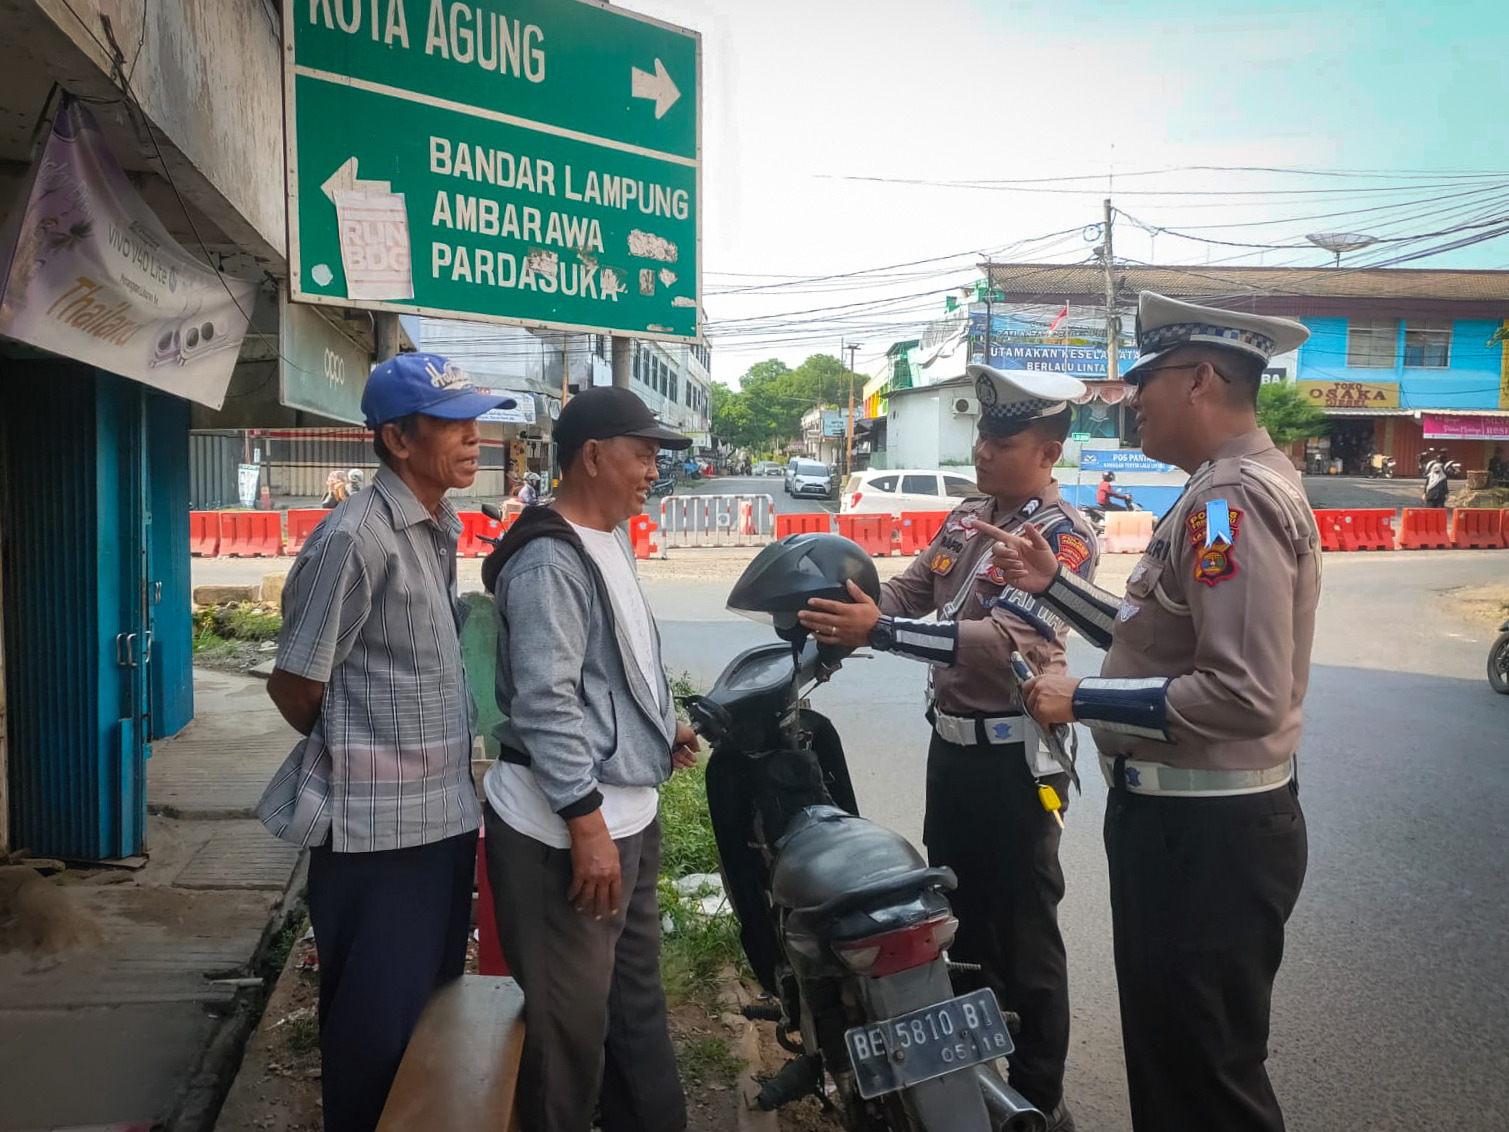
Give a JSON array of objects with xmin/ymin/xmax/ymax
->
[{"xmin": 284, "ymin": 0, "xmax": 702, "ymax": 340}]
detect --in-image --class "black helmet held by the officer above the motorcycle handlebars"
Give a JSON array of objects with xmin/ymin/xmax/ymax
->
[{"xmin": 729, "ymin": 534, "xmax": 880, "ymax": 641}]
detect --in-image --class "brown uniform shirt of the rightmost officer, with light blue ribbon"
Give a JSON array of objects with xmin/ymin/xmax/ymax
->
[{"xmin": 1044, "ymin": 429, "xmax": 1320, "ymax": 770}]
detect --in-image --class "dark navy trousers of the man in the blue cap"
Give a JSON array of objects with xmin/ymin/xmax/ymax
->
[{"xmin": 309, "ymin": 833, "xmax": 477, "ymax": 1132}]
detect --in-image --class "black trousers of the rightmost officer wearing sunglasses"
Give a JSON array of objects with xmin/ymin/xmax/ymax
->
[{"xmin": 1106, "ymin": 785, "xmax": 1307, "ymax": 1132}]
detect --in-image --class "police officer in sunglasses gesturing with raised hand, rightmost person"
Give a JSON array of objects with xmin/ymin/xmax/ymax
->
[{"xmin": 994, "ymin": 291, "xmax": 1320, "ymax": 1132}]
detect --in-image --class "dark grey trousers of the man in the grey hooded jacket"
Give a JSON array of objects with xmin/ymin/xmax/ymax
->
[{"xmin": 486, "ymin": 806, "xmax": 687, "ymax": 1132}]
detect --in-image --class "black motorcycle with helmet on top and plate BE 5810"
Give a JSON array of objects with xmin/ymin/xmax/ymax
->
[{"xmin": 687, "ymin": 534, "xmax": 1047, "ymax": 1132}]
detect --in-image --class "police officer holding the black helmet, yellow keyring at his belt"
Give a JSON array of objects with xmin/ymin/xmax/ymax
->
[{"xmin": 801, "ymin": 365, "xmax": 1099, "ymax": 1132}]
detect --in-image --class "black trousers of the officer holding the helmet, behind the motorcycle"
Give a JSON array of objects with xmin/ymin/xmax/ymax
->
[{"xmin": 922, "ymin": 735, "xmax": 1068, "ymax": 1112}]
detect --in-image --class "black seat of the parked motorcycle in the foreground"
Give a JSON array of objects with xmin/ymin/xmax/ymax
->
[{"xmin": 770, "ymin": 806, "xmax": 952, "ymax": 910}]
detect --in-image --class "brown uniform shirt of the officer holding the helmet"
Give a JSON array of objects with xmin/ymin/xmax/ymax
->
[{"xmin": 880, "ymin": 481, "xmax": 1100, "ymax": 715}]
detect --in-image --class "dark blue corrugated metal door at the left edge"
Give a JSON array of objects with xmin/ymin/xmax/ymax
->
[{"xmin": 0, "ymin": 359, "xmax": 152, "ymax": 859}]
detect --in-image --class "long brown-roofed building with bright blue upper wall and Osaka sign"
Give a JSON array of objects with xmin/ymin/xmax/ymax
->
[{"xmin": 990, "ymin": 264, "xmax": 1509, "ymax": 475}]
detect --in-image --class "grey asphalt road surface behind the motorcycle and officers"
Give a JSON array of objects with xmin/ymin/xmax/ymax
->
[{"xmin": 646, "ymin": 551, "xmax": 1509, "ymax": 1132}]
